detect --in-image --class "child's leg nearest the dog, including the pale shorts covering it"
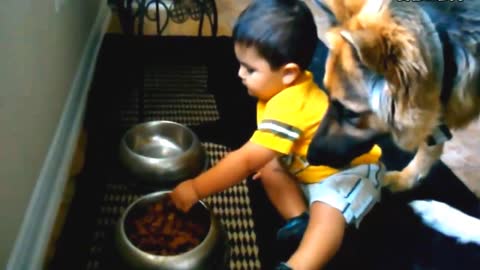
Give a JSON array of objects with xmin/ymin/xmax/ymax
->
[{"xmin": 279, "ymin": 164, "xmax": 385, "ymax": 269}]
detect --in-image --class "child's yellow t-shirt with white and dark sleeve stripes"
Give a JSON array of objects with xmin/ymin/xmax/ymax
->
[{"xmin": 250, "ymin": 71, "xmax": 381, "ymax": 183}]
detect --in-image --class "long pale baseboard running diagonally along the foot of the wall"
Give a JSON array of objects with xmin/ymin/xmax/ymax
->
[{"xmin": 6, "ymin": 4, "xmax": 111, "ymax": 270}]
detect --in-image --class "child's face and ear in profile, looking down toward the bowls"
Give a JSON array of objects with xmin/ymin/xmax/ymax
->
[{"xmin": 235, "ymin": 43, "xmax": 285, "ymax": 101}]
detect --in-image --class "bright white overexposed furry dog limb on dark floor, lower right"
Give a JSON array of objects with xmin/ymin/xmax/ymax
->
[{"xmin": 409, "ymin": 200, "xmax": 480, "ymax": 245}]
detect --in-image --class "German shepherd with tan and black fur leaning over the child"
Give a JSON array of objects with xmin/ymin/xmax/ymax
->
[{"xmin": 308, "ymin": 0, "xmax": 480, "ymax": 244}]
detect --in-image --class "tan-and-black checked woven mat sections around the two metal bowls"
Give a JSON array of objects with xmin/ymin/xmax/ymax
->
[{"xmin": 86, "ymin": 65, "xmax": 261, "ymax": 270}]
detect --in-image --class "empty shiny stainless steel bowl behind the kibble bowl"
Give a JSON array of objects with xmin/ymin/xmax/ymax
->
[{"xmin": 120, "ymin": 121, "xmax": 207, "ymax": 187}]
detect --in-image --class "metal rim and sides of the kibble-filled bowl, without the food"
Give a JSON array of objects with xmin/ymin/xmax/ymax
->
[{"xmin": 114, "ymin": 191, "xmax": 230, "ymax": 270}]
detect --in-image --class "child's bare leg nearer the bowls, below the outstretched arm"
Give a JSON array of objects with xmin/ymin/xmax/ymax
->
[{"xmin": 260, "ymin": 159, "xmax": 307, "ymax": 220}]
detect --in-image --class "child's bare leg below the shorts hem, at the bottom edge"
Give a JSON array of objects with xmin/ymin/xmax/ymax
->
[{"xmin": 287, "ymin": 201, "xmax": 346, "ymax": 269}]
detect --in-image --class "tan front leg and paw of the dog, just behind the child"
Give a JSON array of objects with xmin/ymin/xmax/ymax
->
[{"xmin": 383, "ymin": 143, "xmax": 443, "ymax": 192}]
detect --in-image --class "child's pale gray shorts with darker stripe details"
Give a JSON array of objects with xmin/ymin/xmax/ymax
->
[{"xmin": 301, "ymin": 163, "xmax": 385, "ymax": 227}]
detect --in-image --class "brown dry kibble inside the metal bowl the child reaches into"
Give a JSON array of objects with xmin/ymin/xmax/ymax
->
[{"xmin": 125, "ymin": 196, "xmax": 209, "ymax": 256}]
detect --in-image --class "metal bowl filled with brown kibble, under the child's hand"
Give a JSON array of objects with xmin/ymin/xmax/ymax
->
[{"xmin": 115, "ymin": 191, "xmax": 229, "ymax": 270}]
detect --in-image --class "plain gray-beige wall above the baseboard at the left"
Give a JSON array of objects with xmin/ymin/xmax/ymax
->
[{"xmin": 0, "ymin": 0, "xmax": 101, "ymax": 269}]
